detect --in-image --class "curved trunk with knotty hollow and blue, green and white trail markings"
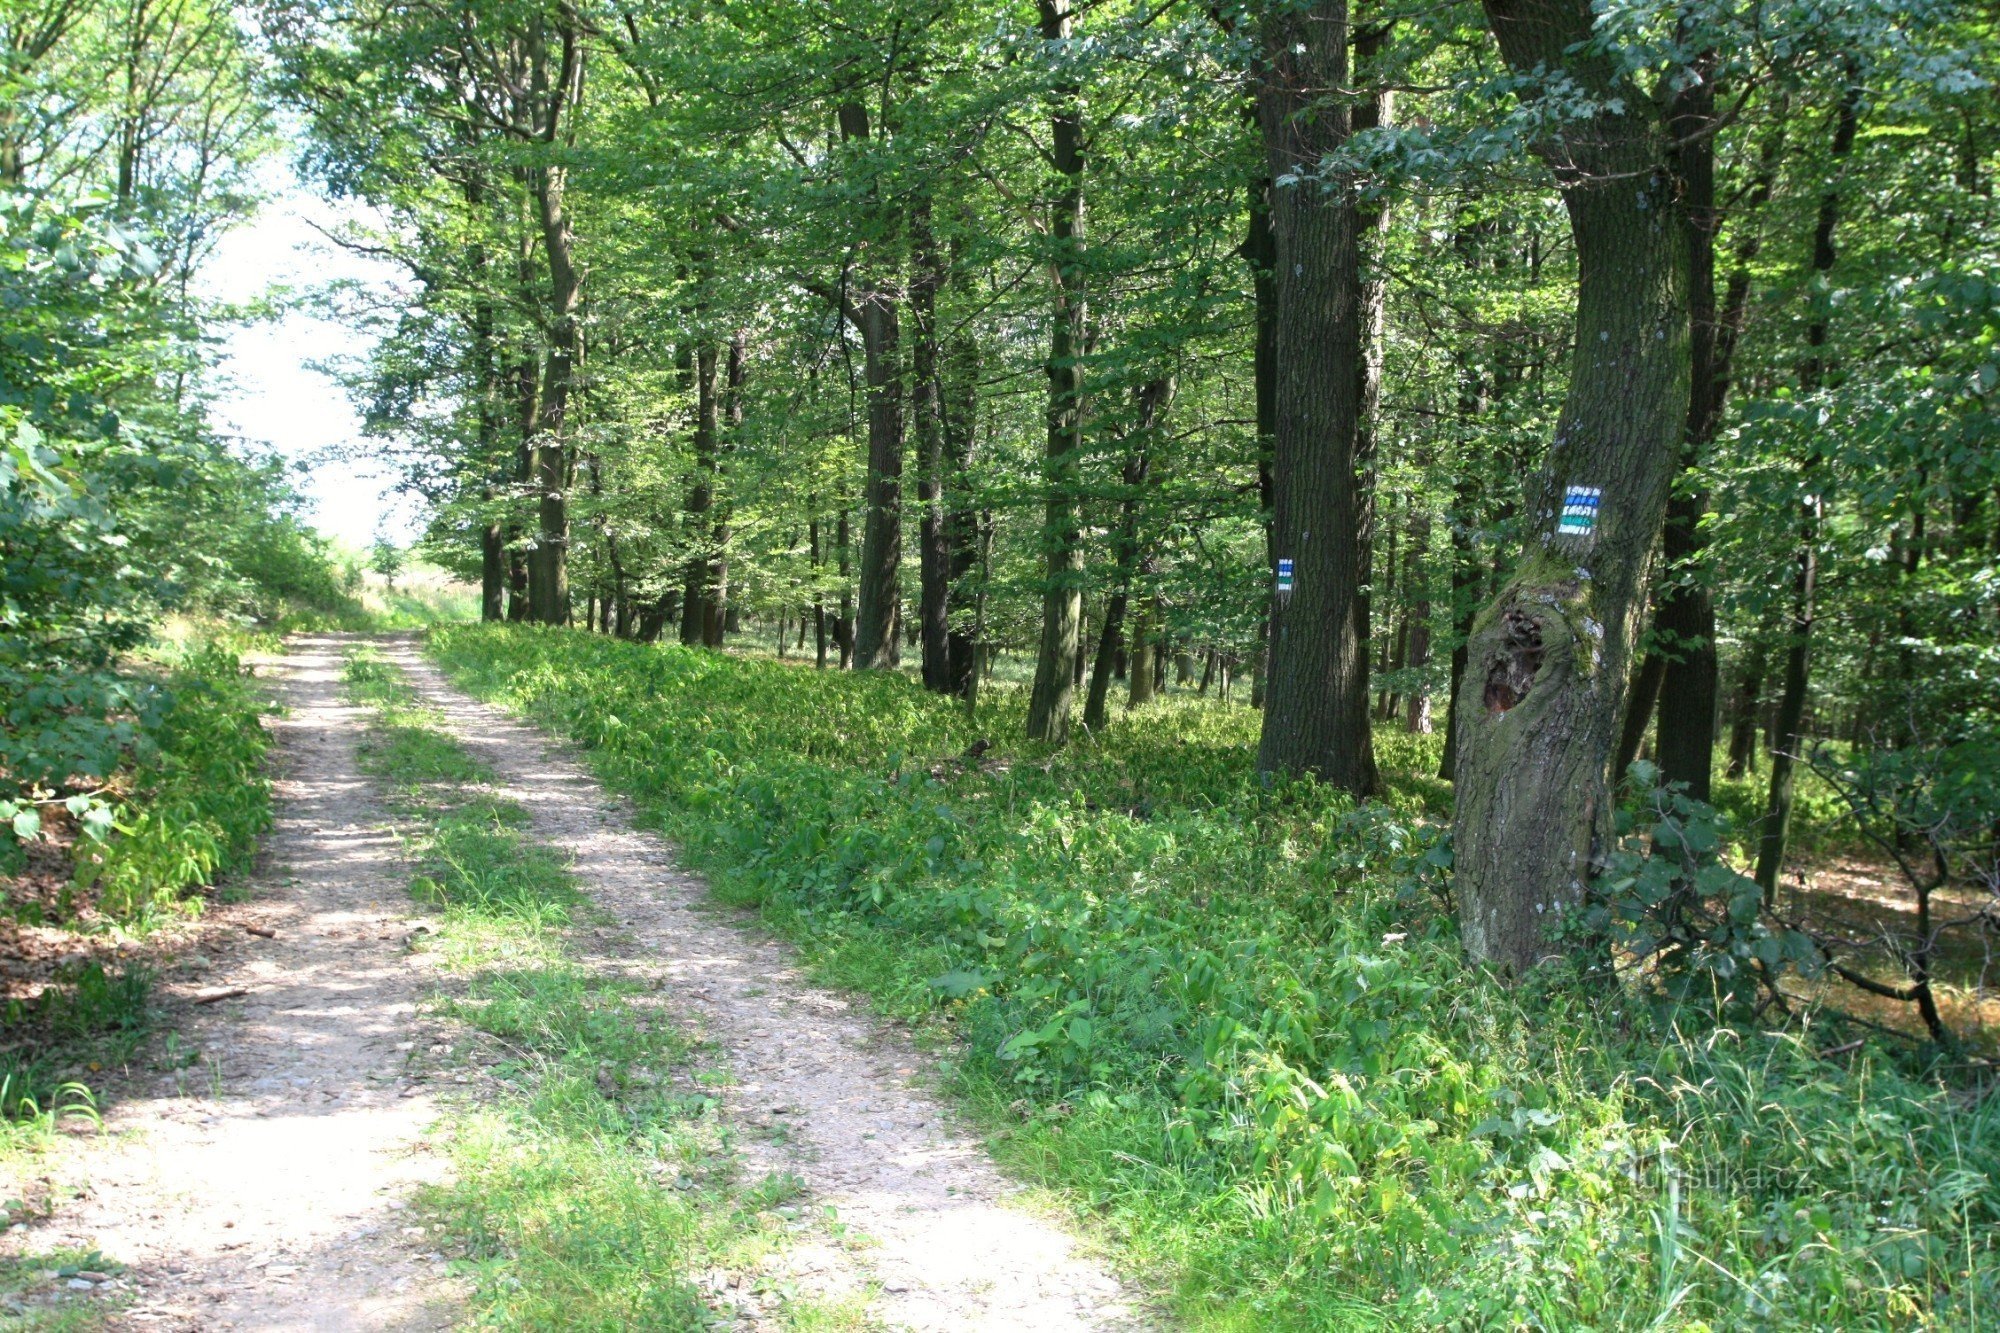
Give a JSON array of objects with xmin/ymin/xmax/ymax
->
[{"xmin": 1454, "ymin": 0, "xmax": 1688, "ymax": 977}]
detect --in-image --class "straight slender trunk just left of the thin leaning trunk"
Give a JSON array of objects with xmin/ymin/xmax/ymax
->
[{"xmin": 1028, "ymin": 0, "xmax": 1084, "ymax": 745}]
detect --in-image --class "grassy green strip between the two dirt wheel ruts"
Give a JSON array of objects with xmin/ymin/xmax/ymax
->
[{"xmin": 346, "ymin": 650, "xmax": 852, "ymax": 1331}]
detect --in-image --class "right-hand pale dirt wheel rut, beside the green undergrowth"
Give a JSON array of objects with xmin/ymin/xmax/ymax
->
[{"xmin": 384, "ymin": 640, "xmax": 1154, "ymax": 1333}]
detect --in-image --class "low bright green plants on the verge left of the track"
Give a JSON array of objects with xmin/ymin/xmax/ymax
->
[{"xmin": 76, "ymin": 644, "xmax": 270, "ymax": 921}]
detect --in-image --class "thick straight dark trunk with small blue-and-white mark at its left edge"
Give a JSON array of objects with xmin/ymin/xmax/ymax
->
[{"xmin": 1258, "ymin": 0, "xmax": 1376, "ymax": 795}]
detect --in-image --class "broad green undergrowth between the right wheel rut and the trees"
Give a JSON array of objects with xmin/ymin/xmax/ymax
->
[{"xmin": 430, "ymin": 626, "xmax": 2000, "ymax": 1329}]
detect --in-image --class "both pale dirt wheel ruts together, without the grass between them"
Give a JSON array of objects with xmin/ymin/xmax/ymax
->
[{"xmin": 0, "ymin": 636, "xmax": 1152, "ymax": 1329}]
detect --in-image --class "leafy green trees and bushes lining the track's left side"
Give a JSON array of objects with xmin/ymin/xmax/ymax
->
[{"xmin": 0, "ymin": 0, "xmax": 346, "ymax": 840}]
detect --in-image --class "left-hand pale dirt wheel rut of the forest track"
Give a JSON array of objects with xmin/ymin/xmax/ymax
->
[{"xmin": 0, "ymin": 636, "xmax": 460, "ymax": 1333}]
